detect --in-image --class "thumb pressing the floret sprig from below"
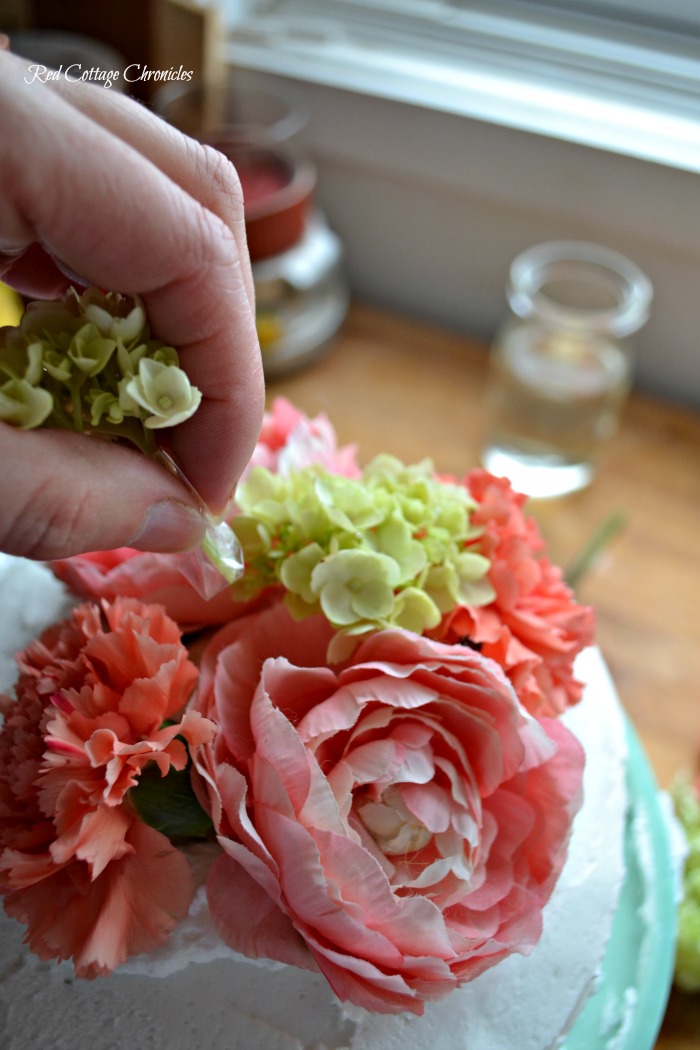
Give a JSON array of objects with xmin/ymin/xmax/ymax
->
[{"xmin": 0, "ymin": 423, "xmax": 207, "ymax": 560}]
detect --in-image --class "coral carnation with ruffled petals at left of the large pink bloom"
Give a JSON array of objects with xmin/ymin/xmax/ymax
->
[{"xmin": 0, "ymin": 599, "xmax": 214, "ymax": 978}]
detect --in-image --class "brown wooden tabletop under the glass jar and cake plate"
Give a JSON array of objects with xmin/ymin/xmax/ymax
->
[{"xmin": 268, "ymin": 305, "xmax": 700, "ymax": 1050}]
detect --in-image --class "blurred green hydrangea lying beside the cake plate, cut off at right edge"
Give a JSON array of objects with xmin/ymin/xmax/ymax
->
[{"xmin": 672, "ymin": 776, "xmax": 700, "ymax": 991}]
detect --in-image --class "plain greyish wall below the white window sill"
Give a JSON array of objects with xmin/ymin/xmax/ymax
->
[{"xmin": 248, "ymin": 75, "xmax": 700, "ymax": 407}]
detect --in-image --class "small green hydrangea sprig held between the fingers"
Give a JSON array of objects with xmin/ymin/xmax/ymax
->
[{"xmin": 0, "ymin": 288, "xmax": 201, "ymax": 454}]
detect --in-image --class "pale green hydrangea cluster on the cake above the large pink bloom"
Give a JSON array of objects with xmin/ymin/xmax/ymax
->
[{"xmin": 230, "ymin": 456, "xmax": 494, "ymax": 635}]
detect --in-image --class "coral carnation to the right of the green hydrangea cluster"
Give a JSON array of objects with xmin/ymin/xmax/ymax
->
[{"xmin": 431, "ymin": 470, "xmax": 595, "ymax": 717}]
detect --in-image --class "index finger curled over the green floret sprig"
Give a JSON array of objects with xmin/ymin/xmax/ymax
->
[{"xmin": 0, "ymin": 54, "xmax": 263, "ymax": 511}]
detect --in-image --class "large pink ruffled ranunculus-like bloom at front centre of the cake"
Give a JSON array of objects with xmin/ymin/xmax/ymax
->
[{"xmin": 194, "ymin": 604, "xmax": 584, "ymax": 1013}]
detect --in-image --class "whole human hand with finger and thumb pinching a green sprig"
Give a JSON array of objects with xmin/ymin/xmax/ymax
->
[{"xmin": 0, "ymin": 49, "xmax": 263, "ymax": 559}]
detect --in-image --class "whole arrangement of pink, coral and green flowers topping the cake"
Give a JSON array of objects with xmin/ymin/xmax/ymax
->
[{"xmin": 0, "ymin": 291, "xmax": 593, "ymax": 1013}]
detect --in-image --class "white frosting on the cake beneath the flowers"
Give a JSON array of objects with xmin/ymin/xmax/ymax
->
[{"xmin": 0, "ymin": 555, "xmax": 627, "ymax": 1050}]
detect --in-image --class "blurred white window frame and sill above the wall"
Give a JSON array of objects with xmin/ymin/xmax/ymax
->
[{"xmin": 219, "ymin": 0, "xmax": 700, "ymax": 171}]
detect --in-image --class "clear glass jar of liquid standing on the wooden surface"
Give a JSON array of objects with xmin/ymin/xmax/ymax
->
[{"xmin": 482, "ymin": 242, "xmax": 652, "ymax": 497}]
